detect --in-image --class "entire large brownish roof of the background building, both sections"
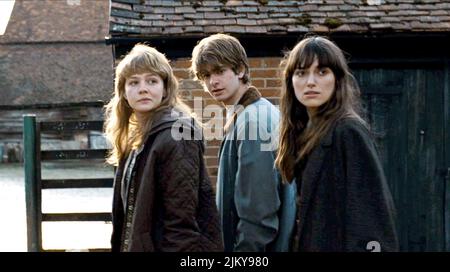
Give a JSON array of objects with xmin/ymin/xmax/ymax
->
[{"xmin": 0, "ymin": 0, "xmax": 114, "ymax": 105}]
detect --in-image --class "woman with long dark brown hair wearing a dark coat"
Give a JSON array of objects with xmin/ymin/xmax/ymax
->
[{"xmin": 276, "ymin": 37, "xmax": 398, "ymax": 251}]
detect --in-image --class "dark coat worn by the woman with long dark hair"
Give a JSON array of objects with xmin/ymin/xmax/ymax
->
[{"xmin": 294, "ymin": 118, "xmax": 398, "ymax": 251}]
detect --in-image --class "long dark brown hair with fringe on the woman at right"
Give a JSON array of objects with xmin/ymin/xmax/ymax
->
[{"xmin": 275, "ymin": 36, "xmax": 368, "ymax": 182}]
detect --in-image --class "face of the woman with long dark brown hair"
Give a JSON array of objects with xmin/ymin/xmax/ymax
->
[{"xmin": 292, "ymin": 59, "xmax": 336, "ymax": 116}]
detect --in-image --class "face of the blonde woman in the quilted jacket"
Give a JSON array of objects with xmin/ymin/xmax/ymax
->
[{"xmin": 125, "ymin": 73, "xmax": 165, "ymax": 115}]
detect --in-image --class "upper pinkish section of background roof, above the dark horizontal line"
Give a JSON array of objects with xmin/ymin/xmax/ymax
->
[{"xmin": 0, "ymin": 0, "xmax": 109, "ymax": 43}]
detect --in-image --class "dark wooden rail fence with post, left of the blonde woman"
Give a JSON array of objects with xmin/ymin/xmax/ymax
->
[{"xmin": 23, "ymin": 115, "xmax": 113, "ymax": 251}]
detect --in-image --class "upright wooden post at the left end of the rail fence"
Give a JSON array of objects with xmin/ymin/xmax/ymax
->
[{"xmin": 23, "ymin": 114, "xmax": 42, "ymax": 252}]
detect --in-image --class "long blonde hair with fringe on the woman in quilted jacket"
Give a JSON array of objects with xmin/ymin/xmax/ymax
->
[{"xmin": 104, "ymin": 44, "xmax": 191, "ymax": 166}]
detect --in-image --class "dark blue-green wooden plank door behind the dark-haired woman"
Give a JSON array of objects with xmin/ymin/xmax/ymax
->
[{"xmin": 354, "ymin": 67, "xmax": 450, "ymax": 251}]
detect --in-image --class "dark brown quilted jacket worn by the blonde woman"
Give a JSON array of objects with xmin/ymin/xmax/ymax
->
[{"xmin": 111, "ymin": 109, "xmax": 223, "ymax": 252}]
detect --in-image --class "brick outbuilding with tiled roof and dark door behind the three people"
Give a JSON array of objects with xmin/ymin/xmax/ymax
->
[{"xmin": 107, "ymin": 0, "xmax": 450, "ymax": 251}]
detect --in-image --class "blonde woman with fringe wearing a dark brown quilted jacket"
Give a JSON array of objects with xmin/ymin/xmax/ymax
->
[{"xmin": 105, "ymin": 44, "xmax": 223, "ymax": 251}]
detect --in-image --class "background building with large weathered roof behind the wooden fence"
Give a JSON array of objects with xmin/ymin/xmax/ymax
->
[{"xmin": 0, "ymin": 0, "xmax": 113, "ymax": 163}]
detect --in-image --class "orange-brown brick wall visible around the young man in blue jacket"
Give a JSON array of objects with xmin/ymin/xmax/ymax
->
[{"xmin": 171, "ymin": 58, "xmax": 281, "ymax": 184}]
